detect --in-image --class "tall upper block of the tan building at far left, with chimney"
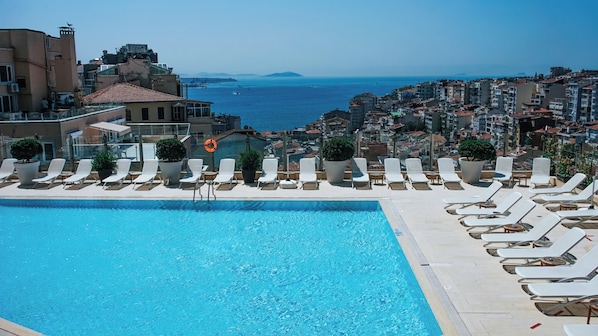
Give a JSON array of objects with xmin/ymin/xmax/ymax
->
[{"xmin": 0, "ymin": 27, "xmax": 81, "ymax": 114}]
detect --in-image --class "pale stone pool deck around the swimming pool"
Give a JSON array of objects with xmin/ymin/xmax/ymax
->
[{"xmin": 0, "ymin": 180, "xmax": 598, "ymax": 336}]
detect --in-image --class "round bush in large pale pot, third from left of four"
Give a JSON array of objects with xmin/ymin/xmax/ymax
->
[{"xmin": 322, "ymin": 137, "xmax": 355, "ymax": 183}]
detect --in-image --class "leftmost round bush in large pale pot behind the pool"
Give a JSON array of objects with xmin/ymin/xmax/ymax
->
[{"xmin": 10, "ymin": 138, "xmax": 43, "ymax": 185}]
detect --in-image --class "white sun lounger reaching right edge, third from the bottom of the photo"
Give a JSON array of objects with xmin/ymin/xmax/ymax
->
[{"xmin": 515, "ymin": 245, "xmax": 598, "ymax": 282}]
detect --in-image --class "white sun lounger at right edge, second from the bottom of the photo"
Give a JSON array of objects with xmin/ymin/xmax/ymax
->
[{"xmin": 527, "ymin": 276, "xmax": 598, "ymax": 313}]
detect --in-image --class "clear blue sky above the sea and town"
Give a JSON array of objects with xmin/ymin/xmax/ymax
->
[{"xmin": 0, "ymin": 0, "xmax": 598, "ymax": 76}]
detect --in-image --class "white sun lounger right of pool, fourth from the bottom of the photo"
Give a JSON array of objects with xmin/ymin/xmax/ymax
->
[{"xmin": 496, "ymin": 227, "xmax": 586, "ymax": 264}]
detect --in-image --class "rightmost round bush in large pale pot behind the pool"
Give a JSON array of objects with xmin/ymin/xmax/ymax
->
[{"xmin": 457, "ymin": 139, "xmax": 496, "ymax": 184}]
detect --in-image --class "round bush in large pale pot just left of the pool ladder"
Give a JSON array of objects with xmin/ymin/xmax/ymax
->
[{"xmin": 156, "ymin": 138, "xmax": 187, "ymax": 185}]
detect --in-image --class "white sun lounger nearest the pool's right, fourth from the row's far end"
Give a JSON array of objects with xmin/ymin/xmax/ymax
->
[{"xmin": 480, "ymin": 213, "xmax": 561, "ymax": 246}]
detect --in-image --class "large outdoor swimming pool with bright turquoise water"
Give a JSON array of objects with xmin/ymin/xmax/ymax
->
[{"xmin": 0, "ymin": 200, "xmax": 442, "ymax": 335}]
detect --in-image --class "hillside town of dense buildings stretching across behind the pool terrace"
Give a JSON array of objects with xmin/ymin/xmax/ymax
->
[{"xmin": 0, "ymin": 26, "xmax": 598, "ymax": 175}]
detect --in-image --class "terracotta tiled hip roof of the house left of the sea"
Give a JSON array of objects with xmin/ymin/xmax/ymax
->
[{"xmin": 83, "ymin": 83, "xmax": 185, "ymax": 104}]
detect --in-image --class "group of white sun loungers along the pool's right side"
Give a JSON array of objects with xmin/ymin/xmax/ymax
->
[{"xmin": 443, "ymin": 173, "xmax": 598, "ymax": 335}]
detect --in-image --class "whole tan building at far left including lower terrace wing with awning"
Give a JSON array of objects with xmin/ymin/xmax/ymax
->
[{"xmin": 0, "ymin": 26, "xmax": 130, "ymax": 163}]
